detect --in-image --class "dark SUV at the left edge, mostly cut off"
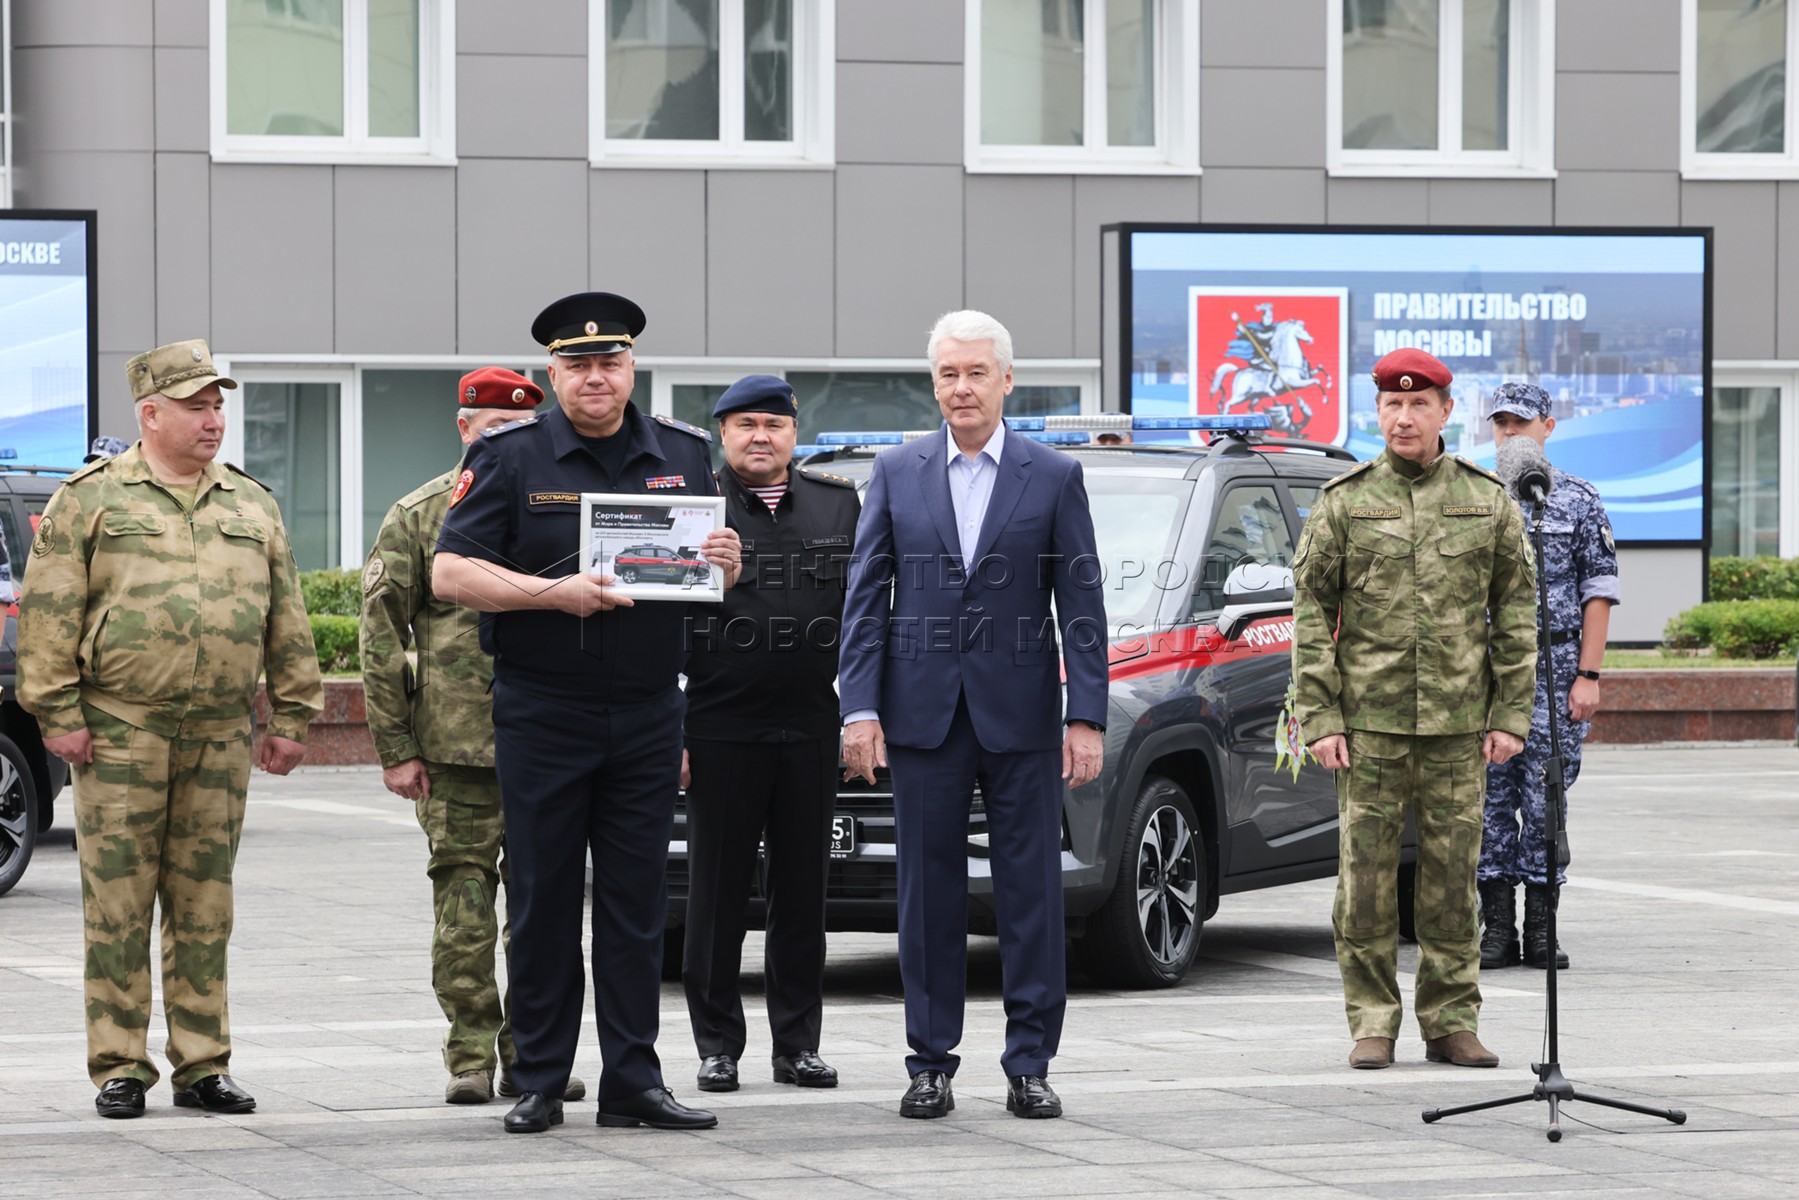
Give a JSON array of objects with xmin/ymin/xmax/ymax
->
[{"xmin": 0, "ymin": 466, "xmax": 68, "ymax": 896}]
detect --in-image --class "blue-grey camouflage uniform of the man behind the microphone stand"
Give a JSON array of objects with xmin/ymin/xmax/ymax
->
[{"xmin": 1481, "ymin": 470, "xmax": 1619, "ymax": 885}]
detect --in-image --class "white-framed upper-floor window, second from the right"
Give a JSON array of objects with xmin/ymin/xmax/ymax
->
[{"xmin": 1326, "ymin": 0, "xmax": 1554, "ymax": 176}]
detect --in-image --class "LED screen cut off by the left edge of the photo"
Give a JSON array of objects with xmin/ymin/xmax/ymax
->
[{"xmin": 0, "ymin": 212, "xmax": 95, "ymax": 468}]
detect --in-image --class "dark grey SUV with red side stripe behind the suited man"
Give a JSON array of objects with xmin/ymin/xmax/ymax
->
[{"xmin": 664, "ymin": 435, "xmax": 1414, "ymax": 988}]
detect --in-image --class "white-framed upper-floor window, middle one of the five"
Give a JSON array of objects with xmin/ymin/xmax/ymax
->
[{"xmin": 964, "ymin": 0, "xmax": 1200, "ymax": 175}]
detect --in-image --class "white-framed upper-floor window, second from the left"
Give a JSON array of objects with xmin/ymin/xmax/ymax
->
[{"xmin": 588, "ymin": 0, "xmax": 837, "ymax": 167}]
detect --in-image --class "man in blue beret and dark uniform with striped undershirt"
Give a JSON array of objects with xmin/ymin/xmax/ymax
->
[{"xmin": 682, "ymin": 374, "xmax": 860, "ymax": 1092}]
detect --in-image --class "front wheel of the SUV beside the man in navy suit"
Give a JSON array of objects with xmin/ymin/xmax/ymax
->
[{"xmin": 1076, "ymin": 775, "xmax": 1205, "ymax": 988}]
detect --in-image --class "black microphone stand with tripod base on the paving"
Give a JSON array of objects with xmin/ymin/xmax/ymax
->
[{"xmin": 1423, "ymin": 488, "xmax": 1686, "ymax": 1142}]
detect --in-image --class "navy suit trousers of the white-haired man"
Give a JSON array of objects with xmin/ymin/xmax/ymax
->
[{"xmin": 887, "ymin": 696, "xmax": 1069, "ymax": 1076}]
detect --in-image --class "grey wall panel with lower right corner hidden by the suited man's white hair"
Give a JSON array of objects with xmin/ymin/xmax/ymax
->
[{"xmin": 837, "ymin": 166, "xmax": 962, "ymax": 358}]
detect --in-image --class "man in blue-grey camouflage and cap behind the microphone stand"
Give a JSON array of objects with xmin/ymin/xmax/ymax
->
[{"xmin": 1479, "ymin": 383, "xmax": 1619, "ymax": 968}]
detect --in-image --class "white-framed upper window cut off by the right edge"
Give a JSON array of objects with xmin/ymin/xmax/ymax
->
[{"xmin": 1680, "ymin": 0, "xmax": 1799, "ymax": 178}]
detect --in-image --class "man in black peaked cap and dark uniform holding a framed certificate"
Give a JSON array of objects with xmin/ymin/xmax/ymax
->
[{"xmin": 432, "ymin": 291, "xmax": 741, "ymax": 1133}]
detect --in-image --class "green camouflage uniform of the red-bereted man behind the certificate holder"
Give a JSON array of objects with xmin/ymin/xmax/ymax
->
[{"xmin": 362, "ymin": 471, "xmax": 513, "ymax": 1076}]
